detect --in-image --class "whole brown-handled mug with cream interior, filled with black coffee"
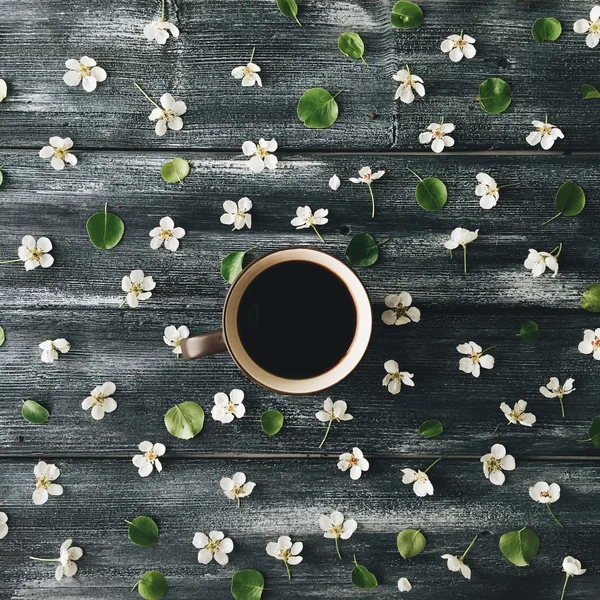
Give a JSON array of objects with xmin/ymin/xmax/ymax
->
[{"xmin": 181, "ymin": 248, "xmax": 372, "ymax": 394}]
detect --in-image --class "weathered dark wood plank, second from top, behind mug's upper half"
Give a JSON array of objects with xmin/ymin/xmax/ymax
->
[{"xmin": 0, "ymin": 151, "xmax": 600, "ymax": 312}]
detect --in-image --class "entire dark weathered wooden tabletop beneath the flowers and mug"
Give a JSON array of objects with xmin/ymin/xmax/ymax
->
[{"xmin": 0, "ymin": 0, "xmax": 600, "ymax": 600}]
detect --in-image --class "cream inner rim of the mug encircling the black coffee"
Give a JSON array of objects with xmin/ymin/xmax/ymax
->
[{"xmin": 222, "ymin": 246, "xmax": 373, "ymax": 395}]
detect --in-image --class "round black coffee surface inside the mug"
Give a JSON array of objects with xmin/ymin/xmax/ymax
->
[{"xmin": 237, "ymin": 261, "xmax": 356, "ymax": 379}]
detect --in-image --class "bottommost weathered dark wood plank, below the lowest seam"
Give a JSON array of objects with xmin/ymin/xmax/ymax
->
[{"xmin": 0, "ymin": 459, "xmax": 600, "ymax": 600}]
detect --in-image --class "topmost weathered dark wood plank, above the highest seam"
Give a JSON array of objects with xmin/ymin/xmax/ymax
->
[{"xmin": 0, "ymin": 0, "xmax": 600, "ymax": 151}]
